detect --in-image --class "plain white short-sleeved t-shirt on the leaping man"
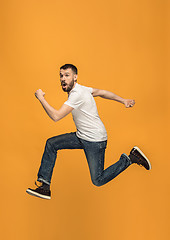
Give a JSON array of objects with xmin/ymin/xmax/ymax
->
[{"xmin": 64, "ymin": 83, "xmax": 107, "ymax": 142}]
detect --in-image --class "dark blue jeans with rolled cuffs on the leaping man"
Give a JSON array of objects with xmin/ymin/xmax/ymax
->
[{"xmin": 37, "ymin": 132, "xmax": 131, "ymax": 186}]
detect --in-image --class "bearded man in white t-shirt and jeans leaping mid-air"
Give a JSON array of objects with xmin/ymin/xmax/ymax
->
[{"xmin": 26, "ymin": 64, "xmax": 151, "ymax": 199}]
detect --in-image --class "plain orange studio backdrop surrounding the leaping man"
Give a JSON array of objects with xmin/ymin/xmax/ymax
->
[{"xmin": 0, "ymin": 0, "xmax": 170, "ymax": 240}]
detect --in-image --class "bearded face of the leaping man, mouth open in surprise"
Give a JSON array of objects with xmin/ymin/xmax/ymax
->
[{"xmin": 60, "ymin": 68, "xmax": 77, "ymax": 92}]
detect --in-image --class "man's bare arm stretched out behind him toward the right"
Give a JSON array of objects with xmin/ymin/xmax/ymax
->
[{"xmin": 92, "ymin": 88, "xmax": 135, "ymax": 107}]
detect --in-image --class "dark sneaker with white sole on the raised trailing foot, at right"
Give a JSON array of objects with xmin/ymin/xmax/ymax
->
[{"xmin": 129, "ymin": 146, "xmax": 151, "ymax": 170}]
